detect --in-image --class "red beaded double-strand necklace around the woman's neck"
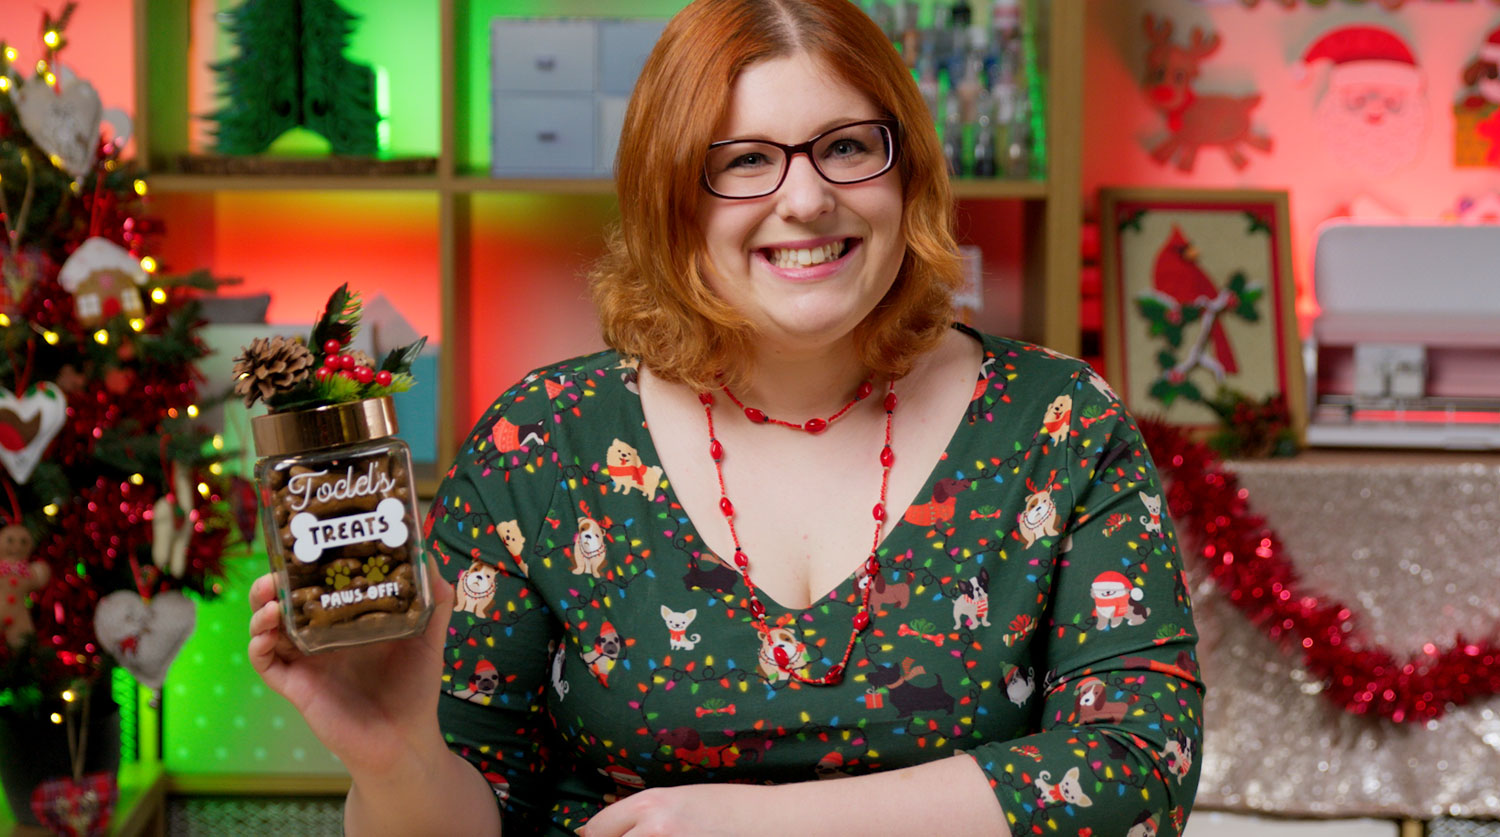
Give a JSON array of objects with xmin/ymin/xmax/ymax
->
[{"xmin": 698, "ymin": 378, "xmax": 896, "ymax": 686}]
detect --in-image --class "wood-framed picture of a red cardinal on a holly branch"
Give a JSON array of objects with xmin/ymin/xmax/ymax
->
[{"xmin": 1100, "ymin": 189, "xmax": 1305, "ymax": 438}]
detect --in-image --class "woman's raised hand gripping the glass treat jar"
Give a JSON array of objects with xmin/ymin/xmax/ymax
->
[{"xmin": 249, "ymin": 560, "xmax": 453, "ymax": 774}]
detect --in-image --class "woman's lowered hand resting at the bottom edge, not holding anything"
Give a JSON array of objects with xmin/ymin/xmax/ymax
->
[{"xmin": 578, "ymin": 785, "xmax": 776, "ymax": 837}]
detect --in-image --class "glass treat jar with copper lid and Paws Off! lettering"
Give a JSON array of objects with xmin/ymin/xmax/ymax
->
[{"xmin": 251, "ymin": 396, "xmax": 432, "ymax": 654}]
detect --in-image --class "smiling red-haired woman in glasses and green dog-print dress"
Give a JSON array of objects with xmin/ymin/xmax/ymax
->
[{"xmin": 251, "ymin": 0, "xmax": 1202, "ymax": 837}]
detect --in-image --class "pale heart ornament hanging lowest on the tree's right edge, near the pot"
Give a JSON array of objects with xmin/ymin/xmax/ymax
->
[{"xmin": 95, "ymin": 590, "xmax": 198, "ymax": 689}]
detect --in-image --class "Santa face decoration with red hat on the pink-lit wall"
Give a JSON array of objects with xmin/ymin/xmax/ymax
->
[{"xmin": 1298, "ymin": 24, "xmax": 1428, "ymax": 176}]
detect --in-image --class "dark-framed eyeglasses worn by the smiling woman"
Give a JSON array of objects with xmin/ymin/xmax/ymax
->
[{"xmin": 704, "ymin": 119, "xmax": 897, "ymax": 201}]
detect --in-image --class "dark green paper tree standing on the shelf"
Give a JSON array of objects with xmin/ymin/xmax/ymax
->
[{"xmin": 209, "ymin": 0, "xmax": 380, "ymax": 156}]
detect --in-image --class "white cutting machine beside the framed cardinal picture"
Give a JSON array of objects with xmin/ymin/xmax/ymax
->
[{"xmin": 1304, "ymin": 224, "xmax": 1500, "ymax": 449}]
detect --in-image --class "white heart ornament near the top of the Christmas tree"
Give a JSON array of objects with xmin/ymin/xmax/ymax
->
[{"xmin": 12, "ymin": 68, "xmax": 104, "ymax": 180}]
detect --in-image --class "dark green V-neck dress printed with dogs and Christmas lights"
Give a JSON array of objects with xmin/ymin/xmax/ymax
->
[{"xmin": 428, "ymin": 329, "xmax": 1203, "ymax": 837}]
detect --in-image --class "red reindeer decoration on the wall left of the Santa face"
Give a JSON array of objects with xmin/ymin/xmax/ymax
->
[{"xmin": 1145, "ymin": 15, "xmax": 1271, "ymax": 171}]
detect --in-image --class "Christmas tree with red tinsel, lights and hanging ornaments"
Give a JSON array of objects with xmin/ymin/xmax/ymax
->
[{"xmin": 0, "ymin": 5, "xmax": 243, "ymax": 725}]
